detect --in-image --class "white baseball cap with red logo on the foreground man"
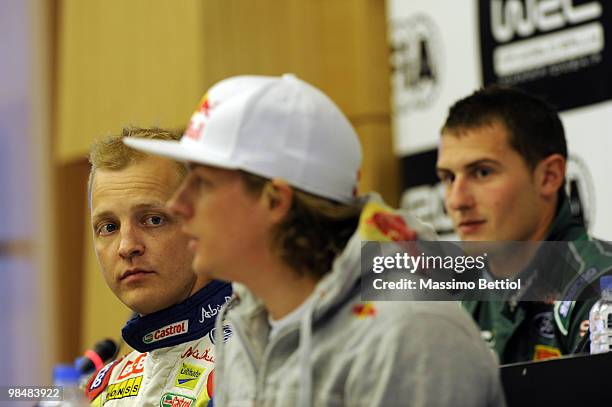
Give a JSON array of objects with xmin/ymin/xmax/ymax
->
[{"xmin": 123, "ymin": 74, "xmax": 361, "ymax": 203}]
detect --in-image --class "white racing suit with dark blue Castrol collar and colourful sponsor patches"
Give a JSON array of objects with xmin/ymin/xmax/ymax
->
[{"xmin": 85, "ymin": 281, "xmax": 232, "ymax": 407}]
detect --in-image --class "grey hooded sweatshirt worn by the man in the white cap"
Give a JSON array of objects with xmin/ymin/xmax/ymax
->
[{"xmin": 214, "ymin": 196, "xmax": 505, "ymax": 407}]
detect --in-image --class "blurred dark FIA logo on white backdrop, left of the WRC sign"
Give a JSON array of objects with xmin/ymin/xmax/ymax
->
[{"xmin": 389, "ymin": 14, "xmax": 443, "ymax": 113}]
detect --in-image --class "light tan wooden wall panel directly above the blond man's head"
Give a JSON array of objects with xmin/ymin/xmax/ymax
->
[{"xmin": 56, "ymin": 0, "xmax": 204, "ymax": 163}]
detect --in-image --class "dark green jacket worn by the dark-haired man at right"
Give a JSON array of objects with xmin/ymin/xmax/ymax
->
[{"xmin": 464, "ymin": 199, "xmax": 612, "ymax": 364}]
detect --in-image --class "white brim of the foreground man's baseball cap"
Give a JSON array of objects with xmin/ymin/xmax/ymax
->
[{"xmin": 123, "ymin": 137, "xmax": 238, "ymax": 169}]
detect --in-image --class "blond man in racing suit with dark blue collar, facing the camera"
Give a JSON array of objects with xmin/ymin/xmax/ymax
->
[{"xmin": 86, "ymin": 128, "xmax": 231, "ymax": 407}]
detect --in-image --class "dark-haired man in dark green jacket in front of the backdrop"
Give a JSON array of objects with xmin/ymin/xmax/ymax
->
[{"xmin": 437, "ymin": 86, "xmax": 612, "ymax": 363}]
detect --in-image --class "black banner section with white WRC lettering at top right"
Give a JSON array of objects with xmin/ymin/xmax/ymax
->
[{"xmin": 479, "ymin": 0, "xmax": 612, "ymax": 111}]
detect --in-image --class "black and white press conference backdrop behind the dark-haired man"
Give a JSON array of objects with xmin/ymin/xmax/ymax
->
[{"xmin": 387, "ymin": 0, "xmax": 612, "ymax": 239}]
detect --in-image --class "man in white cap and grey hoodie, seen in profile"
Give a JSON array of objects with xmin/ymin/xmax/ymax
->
[{"xmin": 124, "ymin": 75, "xmax": 504, "ymax": 406}]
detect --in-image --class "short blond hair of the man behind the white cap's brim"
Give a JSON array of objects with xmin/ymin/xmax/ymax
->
[{"xmin": 87, "ymin": 127, "xmax": 187, "ymax": 208}]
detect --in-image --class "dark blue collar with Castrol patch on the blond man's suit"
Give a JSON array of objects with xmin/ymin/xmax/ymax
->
[{"xmin": 121, "ymin": 281, "xmax": 232, "ymax": 352}]
